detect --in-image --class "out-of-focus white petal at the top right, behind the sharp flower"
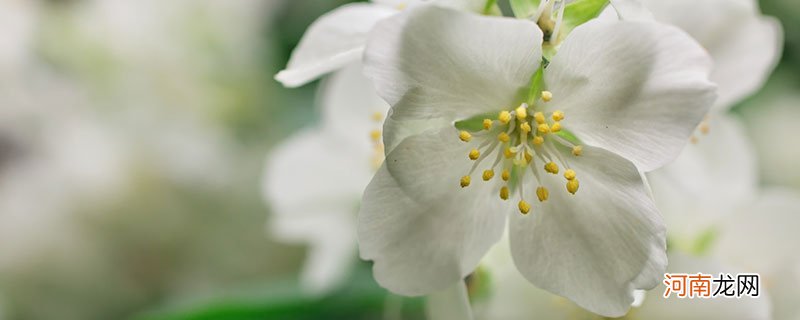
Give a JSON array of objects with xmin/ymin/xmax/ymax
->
[{"xmin": 644, "ymin": 0, "xmax": 783, "ymax": 110}]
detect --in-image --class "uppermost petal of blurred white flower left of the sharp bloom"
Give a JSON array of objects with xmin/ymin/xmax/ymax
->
[{"xmin": 319, "ymin": 63, "xmax": 389, "ymax": 145}]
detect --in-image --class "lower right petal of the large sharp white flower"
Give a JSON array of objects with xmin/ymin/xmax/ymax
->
[{"xmin": 509, "ymin": 146, "xmax": 667, "ymax": 317}]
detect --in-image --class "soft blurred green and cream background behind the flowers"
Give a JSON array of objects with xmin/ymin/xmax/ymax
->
[{"xmin": 0, "ymin": 0, "xmax": 800, "ymax": 320}]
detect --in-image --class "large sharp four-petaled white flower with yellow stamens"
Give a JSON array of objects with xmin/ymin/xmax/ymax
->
[{"xmin": 358, "ymin": 6, "xmax": 714, "ymax": 316}]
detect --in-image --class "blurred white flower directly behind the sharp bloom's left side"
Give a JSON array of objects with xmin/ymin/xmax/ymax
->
[{"xmin": 264, "ymin": 64, "xmax": 389, "ymax": 293}]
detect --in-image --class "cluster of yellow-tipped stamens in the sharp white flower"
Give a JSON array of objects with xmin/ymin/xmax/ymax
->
[{"xmin": 458, "ymin": 91, "xmax": 582, "ymax": 214}]
